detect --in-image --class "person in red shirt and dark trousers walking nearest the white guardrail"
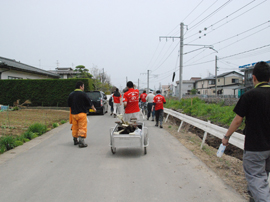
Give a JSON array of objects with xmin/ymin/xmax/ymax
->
[{"xmin": 152, "ymin": 90, "xmax": 166, "ymax": 128}]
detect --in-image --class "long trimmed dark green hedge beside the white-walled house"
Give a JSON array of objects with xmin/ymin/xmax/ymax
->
[{"xmin": 0, "ymin": 78, "xmax": 94, "ymax": 107}]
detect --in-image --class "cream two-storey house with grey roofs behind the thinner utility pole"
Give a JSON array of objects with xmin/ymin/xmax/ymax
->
[{"xmin": 195, "ymin": 71, "xmax": 244, "ymax": 95}]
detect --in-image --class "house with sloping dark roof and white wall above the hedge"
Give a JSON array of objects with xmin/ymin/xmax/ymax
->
[{"xmin": 0, "ymin": 57, "xmax": 60, "ymax": 79}]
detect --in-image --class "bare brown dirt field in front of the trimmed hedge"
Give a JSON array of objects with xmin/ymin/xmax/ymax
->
[{"xmin": 0, "ymin": 109, "xmax": 69, "ymax": 137}]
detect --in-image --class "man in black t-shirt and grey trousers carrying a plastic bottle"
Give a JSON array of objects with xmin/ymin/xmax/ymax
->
[{"xmin": 222, "ymin": 62, "xmax": 270, "ymax": 201}]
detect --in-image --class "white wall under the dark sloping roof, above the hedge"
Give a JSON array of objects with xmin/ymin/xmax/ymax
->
[{"xmin": 0, "ymin": 68, "xmax": 53, "ymax": 79}]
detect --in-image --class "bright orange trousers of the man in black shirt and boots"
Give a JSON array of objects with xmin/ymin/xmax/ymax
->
[{"xmin": 71, "ymin": 113, "xmax": 87, "ymax": 138}]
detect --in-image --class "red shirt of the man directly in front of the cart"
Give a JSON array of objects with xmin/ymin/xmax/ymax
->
[{"xmin": 123, "ymin": 88, "xmax": 140, "ymax": 114}]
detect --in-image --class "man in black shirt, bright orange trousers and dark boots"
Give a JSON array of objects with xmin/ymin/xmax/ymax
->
[{"xmin": 68, "ymin": 81, "xmax": 96, "ymax": 148}]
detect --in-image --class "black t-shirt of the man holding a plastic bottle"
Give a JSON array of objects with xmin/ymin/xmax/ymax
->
[{"xmin": 233, "ymin": 83, "xmax": 270, "ymax": 151}]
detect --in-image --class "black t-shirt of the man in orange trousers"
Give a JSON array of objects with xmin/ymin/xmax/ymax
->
[{"xmin": 68, "ymin": 91, "xmax": 92, "ymax": 114}]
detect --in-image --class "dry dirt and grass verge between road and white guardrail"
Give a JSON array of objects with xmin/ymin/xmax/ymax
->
[{"xmin": 163, "ymin": 120, "xmax": 248, "ymax": 199}]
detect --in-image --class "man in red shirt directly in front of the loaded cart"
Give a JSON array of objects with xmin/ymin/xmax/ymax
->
[{"xmin": 123, "ymin": 81, "xmax": 140, "ymax": 121}]
